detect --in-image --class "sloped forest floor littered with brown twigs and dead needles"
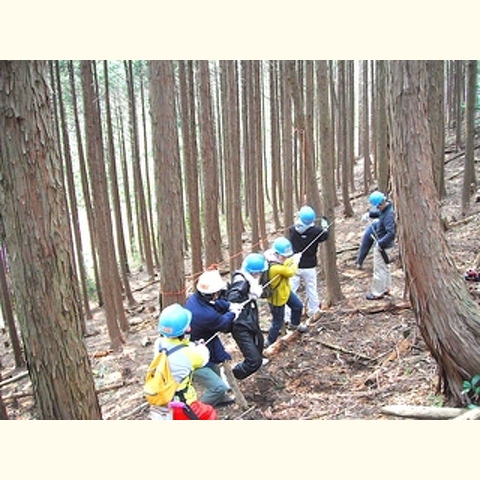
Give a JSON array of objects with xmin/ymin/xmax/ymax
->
[{"xmin": 0, "ymin": 136, "xmax": 480, "ymax": 420}]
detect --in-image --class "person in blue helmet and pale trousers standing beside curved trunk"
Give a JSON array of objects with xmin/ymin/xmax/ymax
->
[{"xmin": 366, "ymin": 190, "xmax": 396, "ymax": 300}]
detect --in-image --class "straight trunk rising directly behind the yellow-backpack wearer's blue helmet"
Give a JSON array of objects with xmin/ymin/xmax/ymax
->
[{"xmin": 150, "ymin": 60, "xmax": 185, "ymax": 308}]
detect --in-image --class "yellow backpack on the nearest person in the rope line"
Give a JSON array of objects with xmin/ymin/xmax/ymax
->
[{"xmin": 143, "ymin": 344, "xmax": 187, "ymax": 406}]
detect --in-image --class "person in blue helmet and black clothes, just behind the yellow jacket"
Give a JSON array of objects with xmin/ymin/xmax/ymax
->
[{"xmin": 227, "ymin": 253, "xmax": 268, "ymax": 380}]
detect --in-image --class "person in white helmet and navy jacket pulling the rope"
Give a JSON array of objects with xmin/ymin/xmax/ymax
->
[{"xmin": 185, "ymin": 269, "xmax": 238, "ymax": 406}]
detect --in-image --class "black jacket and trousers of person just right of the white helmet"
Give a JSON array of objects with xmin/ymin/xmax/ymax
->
[{"xmin": 227, "ymin": 271, "xmax": 264, "ymax": 380}]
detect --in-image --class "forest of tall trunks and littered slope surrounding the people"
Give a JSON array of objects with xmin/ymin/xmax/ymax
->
[{"xmin": 0, "ymin": 60, "xmax": 480, "ymax": 420}]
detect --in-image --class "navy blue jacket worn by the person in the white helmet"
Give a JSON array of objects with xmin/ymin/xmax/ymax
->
[{"xmin": 185, "ymin": 292, "xmax": 235, "ymax": 364}]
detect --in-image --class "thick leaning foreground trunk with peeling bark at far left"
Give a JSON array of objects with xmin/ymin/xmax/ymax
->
[{"xmin": 0, "ymin": 61, "xmax": 101, "ymax": 420}]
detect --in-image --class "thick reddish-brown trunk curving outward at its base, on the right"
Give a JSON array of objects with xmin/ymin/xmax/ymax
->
[{"xmin": 388, "ymin": 61, "xmax": 480, "ymax": 404}]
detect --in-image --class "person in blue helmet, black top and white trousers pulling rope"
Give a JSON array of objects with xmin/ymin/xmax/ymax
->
[{"xmin": 285, "ymin": 205, "xmax": 329, "ymax": 322}]
